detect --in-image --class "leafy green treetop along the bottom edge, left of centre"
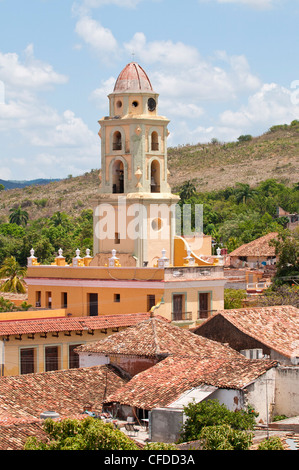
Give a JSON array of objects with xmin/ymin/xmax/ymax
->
[{"xmin": 24, "ymin": 417, "xmax": 138, "ymax": 450}]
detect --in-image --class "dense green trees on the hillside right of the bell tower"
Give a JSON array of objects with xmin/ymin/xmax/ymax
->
[{"xmin": 179, "ymin": 179, "xmax": 299, "ymax": 252}]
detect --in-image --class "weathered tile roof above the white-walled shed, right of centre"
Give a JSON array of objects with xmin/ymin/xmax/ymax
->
[{"xmin": 105, "ymin": 355, "xmax": 277, "ymax": 410}]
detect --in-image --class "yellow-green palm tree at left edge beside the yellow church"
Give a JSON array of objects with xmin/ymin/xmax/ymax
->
[{"xmin": 0, "ymin": 256, "xmax": 26, "ymax": 294}]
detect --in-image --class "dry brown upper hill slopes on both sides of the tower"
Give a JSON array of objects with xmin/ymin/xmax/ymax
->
[{"xmin": 0, "ymin": 121, "xmax": 299, "ymax": 222}]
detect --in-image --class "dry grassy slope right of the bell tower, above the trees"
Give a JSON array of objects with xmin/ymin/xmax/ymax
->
[{"xmin": 168, "ymin": 123, "xmax": 299, "ymax": 191}]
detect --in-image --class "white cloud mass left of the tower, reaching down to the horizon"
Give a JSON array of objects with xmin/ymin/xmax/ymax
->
[{"xmin": 0, "ymin": 45, "xmax": 99, "ymax": 179}]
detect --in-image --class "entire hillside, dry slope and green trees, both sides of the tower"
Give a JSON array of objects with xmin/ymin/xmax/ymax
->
[{"xmin": 0, "ymin": 121, "xmax": 299, "ymax": 266}]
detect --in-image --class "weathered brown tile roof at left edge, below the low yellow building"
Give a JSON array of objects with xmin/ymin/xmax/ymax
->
[{"xmin": 0, "ymin": 366, "xmax": 127, "ymax": 425}]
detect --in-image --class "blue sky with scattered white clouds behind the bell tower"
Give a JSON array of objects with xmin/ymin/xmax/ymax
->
[{"xmin": 0, "ymin": 0, "xmax": 299, "ymax": 180}]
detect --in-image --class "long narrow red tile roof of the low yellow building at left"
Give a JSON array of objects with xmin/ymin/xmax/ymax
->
[{"xmin": 0, "ymin": 313, "xmax": 150, "ymax": 336}]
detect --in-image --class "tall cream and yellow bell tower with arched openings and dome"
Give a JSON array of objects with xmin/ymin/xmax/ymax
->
[{"xmin": 94, "ymin": 62, "xmax": 178, "ymax": 267}]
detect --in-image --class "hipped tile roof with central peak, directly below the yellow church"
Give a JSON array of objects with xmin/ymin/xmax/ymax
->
[{"xmin": 76, "ymin": 317, "xmax": 243, "ymax": 357}]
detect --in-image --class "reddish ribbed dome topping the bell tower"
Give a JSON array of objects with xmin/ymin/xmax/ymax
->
[{"xmin": 114, "ymin": 62, "xmax": 153, "ymax": 92}]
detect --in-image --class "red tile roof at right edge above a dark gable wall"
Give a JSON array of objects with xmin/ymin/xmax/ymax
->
[{"xmin": 194, "ymin": 305, "xmax": 299, "ymax": 358}]
